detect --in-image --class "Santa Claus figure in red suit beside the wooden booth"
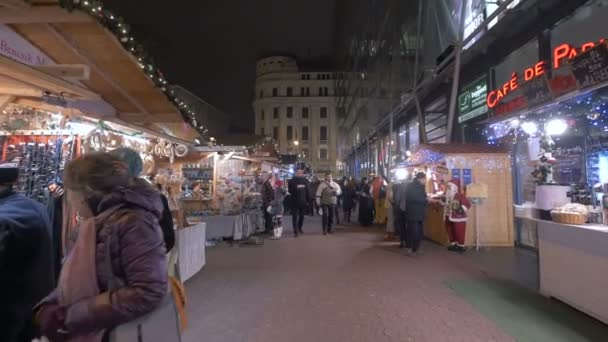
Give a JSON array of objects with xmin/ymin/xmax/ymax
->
[{"xmin": 445, "ymin": 179, "xmax": 471, "ymax": 252}]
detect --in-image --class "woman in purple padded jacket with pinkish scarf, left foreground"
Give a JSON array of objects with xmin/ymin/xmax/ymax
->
[{"xmin": 36, "ymin": 154, "xmax": 168, "ymax": 342}]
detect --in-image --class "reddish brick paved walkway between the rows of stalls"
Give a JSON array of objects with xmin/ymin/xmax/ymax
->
[{"xmin": 184, "ymin": 217, "xmax": 513, "ymax": 342}]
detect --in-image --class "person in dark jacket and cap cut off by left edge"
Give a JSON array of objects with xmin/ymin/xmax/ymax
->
[{"xmin": 0, "ymin": 163, "xmax": 54, "ymax": 342}]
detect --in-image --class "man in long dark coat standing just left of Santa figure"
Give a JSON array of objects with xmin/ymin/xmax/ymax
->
[{"xmin": 405, "ymin": 172, "xmax": 428, "ymax": 255}]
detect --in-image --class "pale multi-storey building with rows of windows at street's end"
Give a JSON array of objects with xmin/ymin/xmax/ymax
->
[{"xmin": 253, "ymin": 56, "xmax": 342, "ymax": 173}]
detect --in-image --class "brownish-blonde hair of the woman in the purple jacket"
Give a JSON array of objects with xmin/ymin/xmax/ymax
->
[{"xmin": 63, "ymin": 153, "xmax": 131, "ymax": 194}]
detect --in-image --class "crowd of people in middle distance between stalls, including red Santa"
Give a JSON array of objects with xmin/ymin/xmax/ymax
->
[{"xmin": 262, "ymin": 170, "xmax": 471, "ymax": 255}]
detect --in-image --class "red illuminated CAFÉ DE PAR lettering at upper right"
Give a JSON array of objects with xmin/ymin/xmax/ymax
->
[{"xmin": 486, "ymin": 39, "xmax": 605, "ymax": 108}]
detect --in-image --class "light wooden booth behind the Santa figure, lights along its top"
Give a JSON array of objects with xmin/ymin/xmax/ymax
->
[{"xmin": 405, "ymin": 143, "xmax": 514, "ymax": 246}]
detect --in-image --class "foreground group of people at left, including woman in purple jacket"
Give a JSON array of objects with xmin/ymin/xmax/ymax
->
[{"xmin": 0, "ymin": 149, "xmax": 179, "ymax": 342}]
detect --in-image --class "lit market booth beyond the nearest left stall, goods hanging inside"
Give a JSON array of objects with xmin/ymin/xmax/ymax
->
[{"xmin": 155, "ymin": 136, "xmax": 280, "ymax": 241}]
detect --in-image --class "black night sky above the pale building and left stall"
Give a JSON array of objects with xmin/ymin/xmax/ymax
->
[{"xmin": 105, "ymin": 0, "xmax": 334, "ymax": 132}]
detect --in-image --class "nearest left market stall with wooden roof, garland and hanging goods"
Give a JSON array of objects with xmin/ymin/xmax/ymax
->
[{"xmin": 0, "ymin": 0, "xmax": 206, "ymax": 280}]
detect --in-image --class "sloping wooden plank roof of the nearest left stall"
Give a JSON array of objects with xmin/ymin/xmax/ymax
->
[{"xmin": 0, "ymin": 0, "xmax": 200, "ymax": 141}]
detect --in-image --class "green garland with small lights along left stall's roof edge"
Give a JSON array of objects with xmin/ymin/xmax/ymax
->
[{"xmin": 59, "ymin": 0, "xmax": 208, "ymax": 138}]
